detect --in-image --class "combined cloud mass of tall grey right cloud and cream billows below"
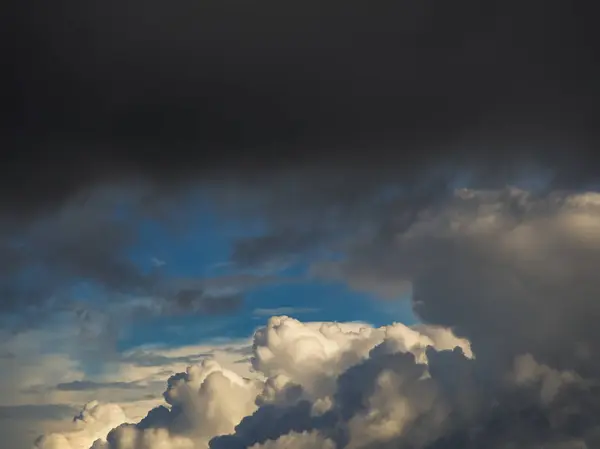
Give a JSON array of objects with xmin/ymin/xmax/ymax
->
[{"xmin": 31, "ymin": 188, "xmax": 600, "ymax": 449}]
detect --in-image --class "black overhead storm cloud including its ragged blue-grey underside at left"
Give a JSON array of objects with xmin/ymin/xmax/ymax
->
[{"xmin": 0, "ymin": 0, "xmax": 600, "ymax": 322}]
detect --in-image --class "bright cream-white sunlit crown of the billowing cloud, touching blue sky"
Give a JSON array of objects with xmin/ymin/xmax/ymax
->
[{"xmin": 252, "ymin": 316, "xmax": 471, "ymax": 398}]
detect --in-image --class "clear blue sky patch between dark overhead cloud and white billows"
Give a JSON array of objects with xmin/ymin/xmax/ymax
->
[{"xmin": 120, "ymin": 208, "xmax": 416, "ymax": 349}]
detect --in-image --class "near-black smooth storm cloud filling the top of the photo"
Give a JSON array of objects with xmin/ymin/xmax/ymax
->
[{"xmin": 1, "ymin": 0, "xmax": 598, "ymax": 214}]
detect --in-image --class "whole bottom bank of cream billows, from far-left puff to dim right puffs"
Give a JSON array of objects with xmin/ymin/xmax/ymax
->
[{"xmin": 36, "ymin": 317, "xmax": 584, "ymax": 449}]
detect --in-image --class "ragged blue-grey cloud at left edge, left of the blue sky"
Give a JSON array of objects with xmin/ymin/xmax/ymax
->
[{"xmin": 0, "ymin": 189, "xmax": 157, "ymax": 312}]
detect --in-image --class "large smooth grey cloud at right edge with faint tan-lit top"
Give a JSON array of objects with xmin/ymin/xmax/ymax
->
[{"xmin": 317, "ymin": 189, "xmax": 600, "ymax": 375}]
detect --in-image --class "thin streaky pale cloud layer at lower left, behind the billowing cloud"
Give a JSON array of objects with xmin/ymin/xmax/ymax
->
[{"xmin": 0, "ymin": 314, "xmax": 252, "ymax": 449}]
